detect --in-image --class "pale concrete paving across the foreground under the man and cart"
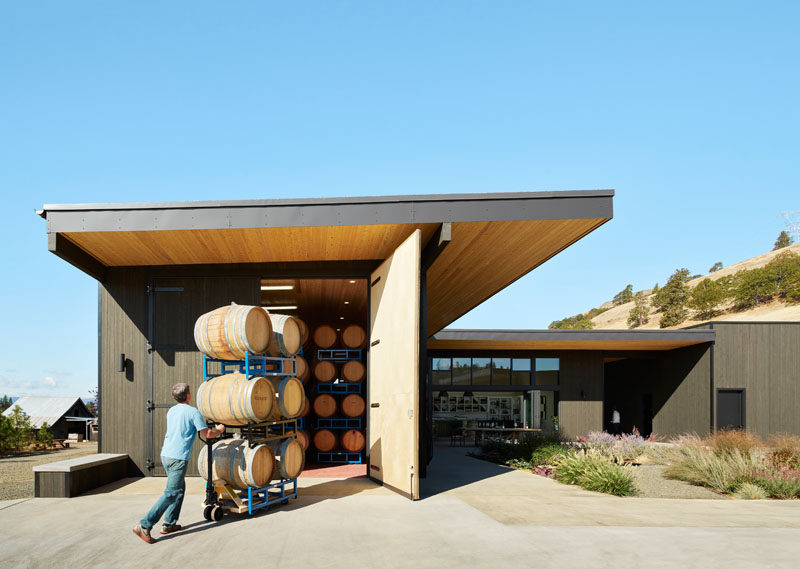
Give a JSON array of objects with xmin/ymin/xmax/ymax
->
[{"xmin": 0, "ymin": 447, "xmax": 800, "ymax": 569}]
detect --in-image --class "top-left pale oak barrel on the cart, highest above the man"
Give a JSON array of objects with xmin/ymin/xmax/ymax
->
[{"xmin": 194, "ymin": 304, "xmax": 272, "ymax": 360}]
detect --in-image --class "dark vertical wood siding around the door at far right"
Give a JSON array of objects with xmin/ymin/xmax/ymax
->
[{"xmin": 714, "ymin": 322, "xmax": 800, "ymax": 437}]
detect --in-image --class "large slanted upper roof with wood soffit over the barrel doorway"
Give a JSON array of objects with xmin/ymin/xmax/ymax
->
[{"xmin": 39, "ymin": 190, "xmax": 614, "ymax": 332}]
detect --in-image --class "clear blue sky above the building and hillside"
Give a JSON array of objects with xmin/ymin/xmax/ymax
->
[{"xmin": 0, "ymin": 1, "xmax": 800, "ymax": 395}]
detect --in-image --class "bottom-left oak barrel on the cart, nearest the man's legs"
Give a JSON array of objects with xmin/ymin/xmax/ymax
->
[{"xmin": 197, "ymin": 439, "xmax": 275, "ymax": 490}]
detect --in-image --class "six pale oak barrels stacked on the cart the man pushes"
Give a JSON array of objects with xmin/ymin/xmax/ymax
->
[{"xmin": 194, "ymin": 304, "xmax": 311, "ymax": 490}]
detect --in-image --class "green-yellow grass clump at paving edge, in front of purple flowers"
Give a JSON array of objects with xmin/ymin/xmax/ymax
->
[{"xmin": 555, "ymin": 449, "xmax": 636, "ymax": 496}]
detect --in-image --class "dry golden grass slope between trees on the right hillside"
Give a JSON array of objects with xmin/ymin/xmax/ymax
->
[{"xmin": 592, "ymin": 243, "xmax": 800, "ymax": 330}]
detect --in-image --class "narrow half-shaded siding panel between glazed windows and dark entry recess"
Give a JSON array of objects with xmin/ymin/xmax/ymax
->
[{"xmin": 558, "ymin": 351, "xmax": 603, "ymax": 437}]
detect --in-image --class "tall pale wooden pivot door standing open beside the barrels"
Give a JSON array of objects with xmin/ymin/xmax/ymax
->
[{"xmin": 367, "ymin": 230, "xmax": 421, "ymax": 499}]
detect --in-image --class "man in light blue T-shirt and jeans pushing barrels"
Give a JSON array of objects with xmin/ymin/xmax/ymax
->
[{"xmin": 133, "ymin": 383, "xmax": 225, "ymax": 543}]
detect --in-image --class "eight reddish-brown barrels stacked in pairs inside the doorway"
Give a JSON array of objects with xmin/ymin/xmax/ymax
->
[{"xmin": 307, "ymin": 324, "xmax": 367, "ymax": 460}]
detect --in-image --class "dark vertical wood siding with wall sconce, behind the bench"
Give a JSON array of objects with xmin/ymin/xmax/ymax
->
[{"xmin": 100, "ymin": 269, "xmax": 148, "ymax": 474}]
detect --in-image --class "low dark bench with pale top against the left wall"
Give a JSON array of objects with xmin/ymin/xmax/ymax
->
[{"xmin": 33, "ymin": 453, "xmax": 128, "ymax": 498}]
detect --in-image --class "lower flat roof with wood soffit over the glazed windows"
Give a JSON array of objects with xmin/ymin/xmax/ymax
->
[{"xmin": 428, "ymin": 329, "xmax": 715, "ymax": 351}]
